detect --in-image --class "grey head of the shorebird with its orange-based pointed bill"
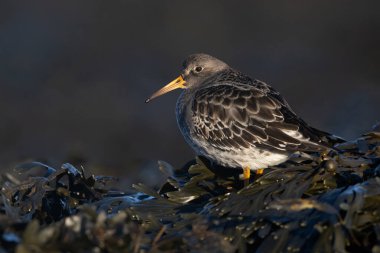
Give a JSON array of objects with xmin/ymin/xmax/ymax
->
[{"xmin": 145, "ymin": 54, "xmax": 230, "ymax": 103}]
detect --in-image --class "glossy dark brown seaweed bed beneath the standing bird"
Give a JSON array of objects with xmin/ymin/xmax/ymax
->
[{"xmin": 0, "ymin": 123, "xmax": 380, "ymax": 253}]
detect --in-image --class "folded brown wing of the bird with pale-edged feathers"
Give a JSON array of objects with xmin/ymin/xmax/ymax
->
[{"xmin": 191, "ymin": 84, "xmax": 326, "ymax": 152}]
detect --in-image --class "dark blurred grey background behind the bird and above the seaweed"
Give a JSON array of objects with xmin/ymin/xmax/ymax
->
[{"xmin": 0, "ymin": 0, "xmax": 380, "ymax": 185}]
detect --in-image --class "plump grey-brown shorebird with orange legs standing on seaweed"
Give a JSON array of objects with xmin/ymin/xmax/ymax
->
[{"xmin": 145, "ymin": 53, "xmax": 340, "ymax": 180}]
